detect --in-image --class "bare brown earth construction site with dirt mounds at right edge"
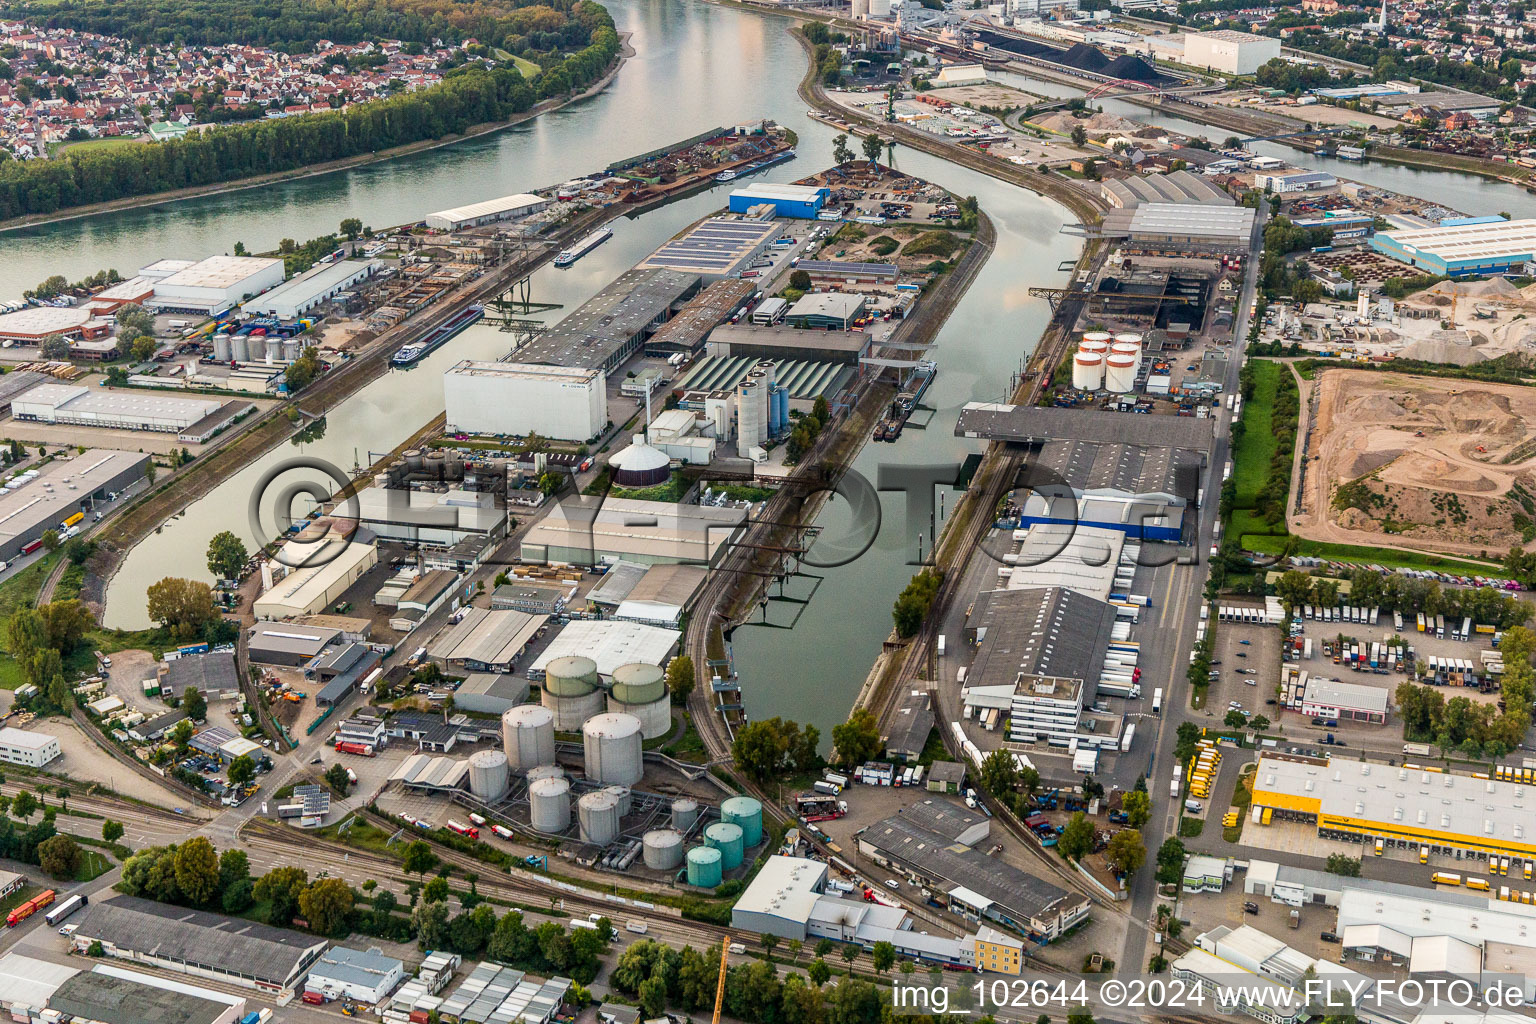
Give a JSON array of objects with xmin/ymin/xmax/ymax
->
[{"xmin": 1292, "ymin": 368, "xmax": 1536, "ymax": 553}]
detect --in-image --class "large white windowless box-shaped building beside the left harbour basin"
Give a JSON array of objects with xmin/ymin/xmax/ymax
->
[{"xmin": 442, "ymin": 359, "xmax": 608, "ymax": 441}]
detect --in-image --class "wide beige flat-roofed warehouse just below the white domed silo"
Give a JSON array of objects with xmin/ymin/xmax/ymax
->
[{"xmin": 521, "ymin": 497, "xmax": 746, "ymax": 565}]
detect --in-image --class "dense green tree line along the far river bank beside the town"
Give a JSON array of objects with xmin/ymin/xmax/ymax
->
[{"xmin": 0, "ymin": 0, "xmax": 619, "ymax": 220}]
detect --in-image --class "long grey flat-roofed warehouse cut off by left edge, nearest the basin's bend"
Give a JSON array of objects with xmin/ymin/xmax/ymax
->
[{"xmin": 0, "ymin": 448, "xmax": 149, "ymax": 562}]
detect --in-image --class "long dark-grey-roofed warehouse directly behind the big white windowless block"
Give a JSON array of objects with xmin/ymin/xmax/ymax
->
[{"xmin": 518, "ymin": 269, "xmax": 700, "ymax": 373}]
